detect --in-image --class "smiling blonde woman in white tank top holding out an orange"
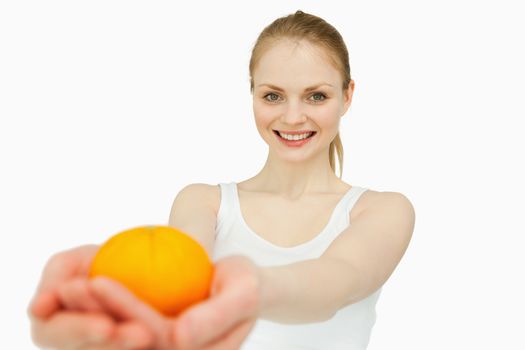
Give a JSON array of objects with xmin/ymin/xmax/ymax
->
[{"xmin": 29, "ymin": 11, "xmax": 415, "ymax": 349}]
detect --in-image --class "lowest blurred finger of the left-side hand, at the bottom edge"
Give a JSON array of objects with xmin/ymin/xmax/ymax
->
[{"xmin": 31, "ymin": 311, "xmax": 115, "ymax": 349}]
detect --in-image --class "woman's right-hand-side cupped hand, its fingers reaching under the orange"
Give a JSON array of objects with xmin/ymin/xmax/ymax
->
[{"xmin": 90, "ymin": 256, "xmax": 261, "ymax": 350}]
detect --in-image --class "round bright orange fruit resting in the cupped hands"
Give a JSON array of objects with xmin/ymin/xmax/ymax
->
[{"xmin": 89, "ymin": 226, "xmax": 213, "ymax": 316}]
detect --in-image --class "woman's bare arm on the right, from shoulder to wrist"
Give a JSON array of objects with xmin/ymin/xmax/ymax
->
[{"xmin": 260, "ymin": 192, "xmax": 415, "ymax": 323}]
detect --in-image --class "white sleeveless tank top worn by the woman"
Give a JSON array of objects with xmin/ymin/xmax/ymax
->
[{"xmin": 212, "ymin": 182, "xmax": 381, "ymax": 350}]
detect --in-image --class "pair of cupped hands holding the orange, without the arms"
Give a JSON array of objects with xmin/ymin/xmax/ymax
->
[{"xmin": 29, "ymin": 246, "xmax": 259, "ymax": 349}]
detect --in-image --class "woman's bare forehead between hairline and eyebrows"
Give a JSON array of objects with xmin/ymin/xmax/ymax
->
[{"xmin": 253, "ymin": 40, "xmax": 342, "ymax": 89}]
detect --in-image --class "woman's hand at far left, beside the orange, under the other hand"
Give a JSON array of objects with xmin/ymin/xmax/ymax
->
[{"xmin": 28, "ymin": 245, "xmax": 154, "ymax": 350}]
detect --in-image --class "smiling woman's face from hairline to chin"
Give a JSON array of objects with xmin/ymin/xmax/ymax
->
[{"xmin": 252, "ymin": 41, "xmax": 353, "ymax": 161}]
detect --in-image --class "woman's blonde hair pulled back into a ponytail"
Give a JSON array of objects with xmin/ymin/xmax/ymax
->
[{"xmin": 249, "ymin": 10, "xmax": 351, "ymax": 178}]
